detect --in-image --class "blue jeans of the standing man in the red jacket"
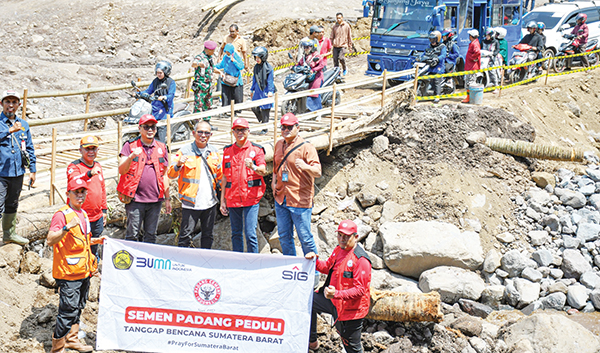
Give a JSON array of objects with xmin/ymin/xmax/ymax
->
[{"xmin": 229, "ymin": 204, "xmax": 259, "ymax": 253}]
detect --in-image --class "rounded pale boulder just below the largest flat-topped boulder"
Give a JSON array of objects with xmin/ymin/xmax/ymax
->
[{"xmin": 419, "ymin": 266, "xmax": 485, "ymax": 304}]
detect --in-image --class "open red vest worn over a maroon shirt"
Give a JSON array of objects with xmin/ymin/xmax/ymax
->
[{"xmin": 117, "ymin": 138, "xmax": 166, "ymax": 199}]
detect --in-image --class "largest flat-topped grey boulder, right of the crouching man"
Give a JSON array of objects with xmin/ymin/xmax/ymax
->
[{"xmin": 379, "ymin": 221, "xmax": 483, "ymax": 278}]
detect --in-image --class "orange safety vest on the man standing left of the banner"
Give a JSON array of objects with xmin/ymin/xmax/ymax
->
[{"xmin": 52, "ymin": 205, "xmax": 98, "ymax": 281}]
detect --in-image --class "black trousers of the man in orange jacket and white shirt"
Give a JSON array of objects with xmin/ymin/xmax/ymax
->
[{"xmin": 177, "ymin": 204, "xmax": 219, "ymax": 249}]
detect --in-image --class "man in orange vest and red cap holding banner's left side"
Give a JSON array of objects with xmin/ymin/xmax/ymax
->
[{"xmin": 46, "ymin": 178, "xmax": 106, "ymax": 353}]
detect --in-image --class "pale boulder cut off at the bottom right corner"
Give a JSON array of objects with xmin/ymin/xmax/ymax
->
[{"xmin": 503, "ymin": 313, "xmax": 600, "ymax": 353}]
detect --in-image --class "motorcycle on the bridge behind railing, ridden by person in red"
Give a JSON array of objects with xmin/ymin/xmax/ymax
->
[{"xmin": 281, "ymin": 60, "xmax": 342, "ymax": 114}]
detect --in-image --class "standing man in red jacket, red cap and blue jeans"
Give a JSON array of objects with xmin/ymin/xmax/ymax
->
[{"xmin": 221, "ymin": 118, "xmax": 267, "ymax": 253}]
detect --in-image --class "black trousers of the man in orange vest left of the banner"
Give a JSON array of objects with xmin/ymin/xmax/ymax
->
[{"xmin": 54, "ymin": 277, "xmax": 90, "ymax": 339}]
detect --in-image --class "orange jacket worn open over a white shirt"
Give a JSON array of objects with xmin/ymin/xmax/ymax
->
[{"xmin": 167, "ymin": 142, "xmax": 223, "ymax": 207}]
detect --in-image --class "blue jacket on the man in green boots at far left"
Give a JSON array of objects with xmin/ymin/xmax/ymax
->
[{"xmin": 0, "ymin": 113, "xmax": 36, "ymax": 177}]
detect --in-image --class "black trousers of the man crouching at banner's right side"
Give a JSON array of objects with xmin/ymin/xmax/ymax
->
[{"xmin": 310, "ymin": 290, "xmax": 363, "ymax": 353}]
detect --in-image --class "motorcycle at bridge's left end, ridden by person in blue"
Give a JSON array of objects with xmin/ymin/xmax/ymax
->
[{"xmin": 123, "ymin": 81, "xmax": 197, "ymax": 142}]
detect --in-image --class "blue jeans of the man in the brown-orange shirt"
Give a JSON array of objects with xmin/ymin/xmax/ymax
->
[{"xmin": 275, "ymin": 199, "xmax": 318, "ymax": 256}]
